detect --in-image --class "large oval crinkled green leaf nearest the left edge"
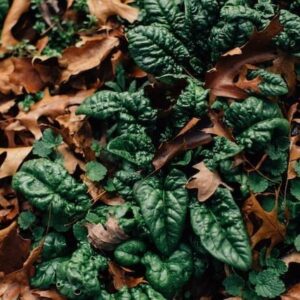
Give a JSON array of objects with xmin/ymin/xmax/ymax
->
[{"xmin": 12, "ymin": 158, "xmax": 91, "ymax": 227}]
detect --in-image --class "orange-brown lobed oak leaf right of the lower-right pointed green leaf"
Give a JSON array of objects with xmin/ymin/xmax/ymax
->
[{"xmin": 243, "ymin": 193, "xmax": 286, "ymax": 254}]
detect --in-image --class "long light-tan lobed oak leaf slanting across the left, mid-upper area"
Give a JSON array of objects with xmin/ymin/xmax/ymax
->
[{"xmin": 16, "ymin": 89, "xmax": 94, "ymax": 140}]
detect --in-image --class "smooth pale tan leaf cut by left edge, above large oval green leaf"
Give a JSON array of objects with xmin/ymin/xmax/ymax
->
[{"xmin": 0, "ymin": 147, "xmax": 32, "ymax": 179}]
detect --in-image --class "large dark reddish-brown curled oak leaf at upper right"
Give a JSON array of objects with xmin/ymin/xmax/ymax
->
[{"xmin": 205, "ymin": 17, "xmax": 283, "ymax": 102}]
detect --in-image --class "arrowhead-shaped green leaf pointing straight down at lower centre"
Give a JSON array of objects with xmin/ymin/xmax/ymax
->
[{"xmin": 134, "ymin": 169, "xmax": 189, "ymax": 255}]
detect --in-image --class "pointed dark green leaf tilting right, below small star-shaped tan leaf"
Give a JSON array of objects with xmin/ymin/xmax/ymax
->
[{"xmin": 191, "ymin": 188, "xmax": 252, "ymax": 270}]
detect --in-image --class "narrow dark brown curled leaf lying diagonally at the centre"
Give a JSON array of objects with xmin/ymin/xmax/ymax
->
[{"xmin": 152, "ymin": 118, "xmax": 212, "ymax": 171}]
